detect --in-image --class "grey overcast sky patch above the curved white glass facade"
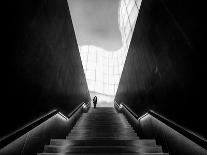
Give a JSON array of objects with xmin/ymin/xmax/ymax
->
[{"xmin": 68, "ymin": 0, "xmax": 122, "ymax": 51}]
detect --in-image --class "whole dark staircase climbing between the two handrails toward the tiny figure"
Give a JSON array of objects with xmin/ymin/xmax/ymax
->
[{"xmin": 38, "ymin": 107, "xmax": 168, "ymax": 155}]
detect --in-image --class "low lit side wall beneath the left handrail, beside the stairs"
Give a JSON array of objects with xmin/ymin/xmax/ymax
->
[{"xmin": 0, "ymin": 107, "xmax": 87, "ymax": 155}]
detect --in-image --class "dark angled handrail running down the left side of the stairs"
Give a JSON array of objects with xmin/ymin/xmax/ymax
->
[{"xmin": 0, "ymin": 103, "xmax": 89, "ymax": 149}]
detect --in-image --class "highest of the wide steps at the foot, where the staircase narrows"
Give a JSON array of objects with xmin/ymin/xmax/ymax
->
[{"xmin": 50, "ymin": 139, "xmax": 156, "ymax": 146}]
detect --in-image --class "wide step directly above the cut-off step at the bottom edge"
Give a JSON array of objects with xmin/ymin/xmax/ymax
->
[{"xmin": 44, "ymin": 145, "xmax": 162, "ymax": 153}]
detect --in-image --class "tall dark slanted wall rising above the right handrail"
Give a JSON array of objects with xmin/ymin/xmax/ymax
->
[{"xmin": 116, "ymin": 0, "xmax": 207, "ymax": 138}]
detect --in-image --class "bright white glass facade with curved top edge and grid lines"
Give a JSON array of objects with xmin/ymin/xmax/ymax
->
[{"xmin": 79, "ymin": 0, "xmax": 141, "ymax": 96}]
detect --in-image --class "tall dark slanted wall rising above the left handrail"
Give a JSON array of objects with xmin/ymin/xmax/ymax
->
[{"xmin": 0, "ymin": 0, "xmax": 90, "ymax": 137}]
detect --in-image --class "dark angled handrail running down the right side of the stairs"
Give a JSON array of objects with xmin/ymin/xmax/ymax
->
[{"xmin": 116, "ymin": 103, "xmax": 207, "ymax": 149}]
